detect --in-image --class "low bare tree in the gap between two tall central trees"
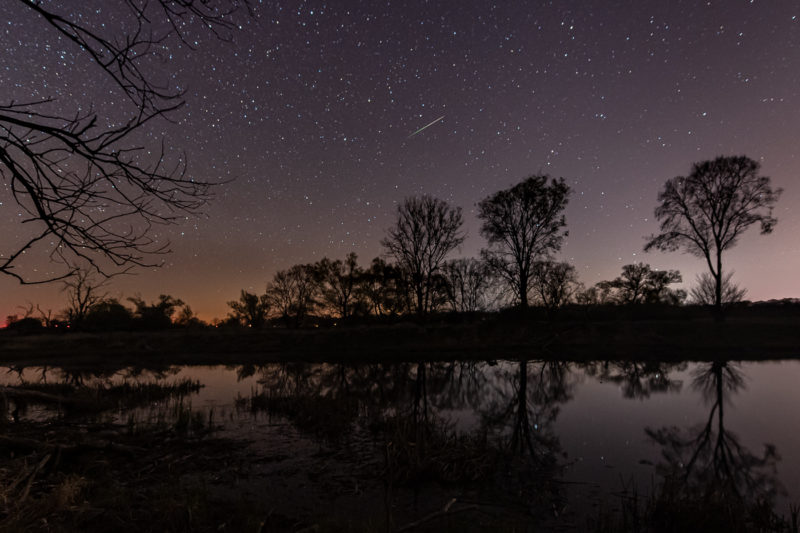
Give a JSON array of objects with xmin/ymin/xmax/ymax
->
[{"xmin": 442, "ymin": 258, "xmax": 493, "ymax": 313}]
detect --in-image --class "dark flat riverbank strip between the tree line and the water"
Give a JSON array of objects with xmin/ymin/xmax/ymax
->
[{"xmin": 0, "ymin": 316, "xmax": 800, "ymax": 365}]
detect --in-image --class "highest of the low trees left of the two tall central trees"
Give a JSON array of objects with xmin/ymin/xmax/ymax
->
[{"xmin": 314, "ymin": 252, "xmax": 364, "ymax": 320}]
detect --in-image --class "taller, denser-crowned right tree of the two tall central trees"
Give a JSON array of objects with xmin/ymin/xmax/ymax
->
[{"xmin": 478, "ymin": 176, "xmax": 570, "ymax": 308}]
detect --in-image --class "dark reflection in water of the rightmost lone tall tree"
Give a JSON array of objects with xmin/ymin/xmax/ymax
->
[{"xmin": 645, "ymin": 361, "xmax": 783, "ymax": 530}]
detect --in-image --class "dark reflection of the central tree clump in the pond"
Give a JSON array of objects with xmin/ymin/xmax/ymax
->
[{"xmin": 243, "ymin": 361, "xmax": 578, "ymax": 529}]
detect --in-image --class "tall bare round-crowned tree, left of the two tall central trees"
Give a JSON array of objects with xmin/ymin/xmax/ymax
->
[{"xmin": 381, "ymin": 196, "xmax": 464, "ymax": 316}]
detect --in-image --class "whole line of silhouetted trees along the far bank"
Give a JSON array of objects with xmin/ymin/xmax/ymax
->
[{"xmin": 4, "ymin": 156, "xmax": 781, "ymax": 328}]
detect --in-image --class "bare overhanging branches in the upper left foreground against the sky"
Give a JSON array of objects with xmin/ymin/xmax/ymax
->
[{"xmin": 0, "ymin": 0, "xmax": 248, "ymax": 283}]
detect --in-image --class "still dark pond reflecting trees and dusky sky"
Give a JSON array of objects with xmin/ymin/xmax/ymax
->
[{"xmin": 0, "ymin": 360, "xmax": 800, "ymax": 530}]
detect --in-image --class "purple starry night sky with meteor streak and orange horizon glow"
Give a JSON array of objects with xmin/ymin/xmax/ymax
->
[{"xmin": 0, "ymin": 0, "xmax": 800, "ymax": 319}]
